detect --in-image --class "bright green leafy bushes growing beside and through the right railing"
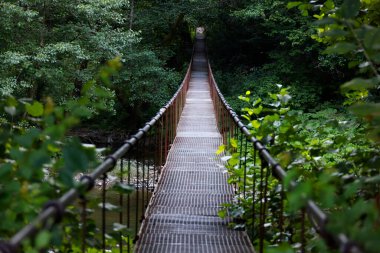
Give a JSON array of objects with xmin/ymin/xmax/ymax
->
[{"xmin": 220, "ymin": 85, "xmax": 380, "ymax": 252}]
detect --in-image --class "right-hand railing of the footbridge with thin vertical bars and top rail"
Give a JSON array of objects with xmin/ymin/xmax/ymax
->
[{"xmin": 208, "ymin": 64, "xmax": 362, "ymax": 253}]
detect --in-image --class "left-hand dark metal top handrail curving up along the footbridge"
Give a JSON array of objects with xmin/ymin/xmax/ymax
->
[{"xmin": 0, "ymin": 52, "xmax": 192, "ymax": 253}]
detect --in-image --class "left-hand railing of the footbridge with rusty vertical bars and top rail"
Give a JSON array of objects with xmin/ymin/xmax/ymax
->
[{"xmin": 0, "ymin": 61, "xmax": 192, "ymax": 253}]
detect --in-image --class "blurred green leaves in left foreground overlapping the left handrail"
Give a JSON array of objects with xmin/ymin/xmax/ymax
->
[{"xmin": 0, "ymin": 59, "xmax": 132, "ymax": 252}]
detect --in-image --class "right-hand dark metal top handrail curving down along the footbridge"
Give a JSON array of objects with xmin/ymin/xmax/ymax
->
[{"xmin": 208, "ymin": 63, "xmax": 362, "ymax": 253}]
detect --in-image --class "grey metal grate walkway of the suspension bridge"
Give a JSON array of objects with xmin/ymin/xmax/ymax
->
[{"xmin": 136, "ymin": 35, "xmax": 253, "ymax": 253}]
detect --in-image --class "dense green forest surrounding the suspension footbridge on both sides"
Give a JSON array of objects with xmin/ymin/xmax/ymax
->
[{"xmin": 0, "ymin": 0, "xmax": 380, "ymax": 252}]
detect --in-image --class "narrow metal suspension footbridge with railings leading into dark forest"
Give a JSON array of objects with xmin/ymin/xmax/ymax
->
[{"xmin": 0, "ymin": 30, "xmax": 361, "ymax": 253}]
